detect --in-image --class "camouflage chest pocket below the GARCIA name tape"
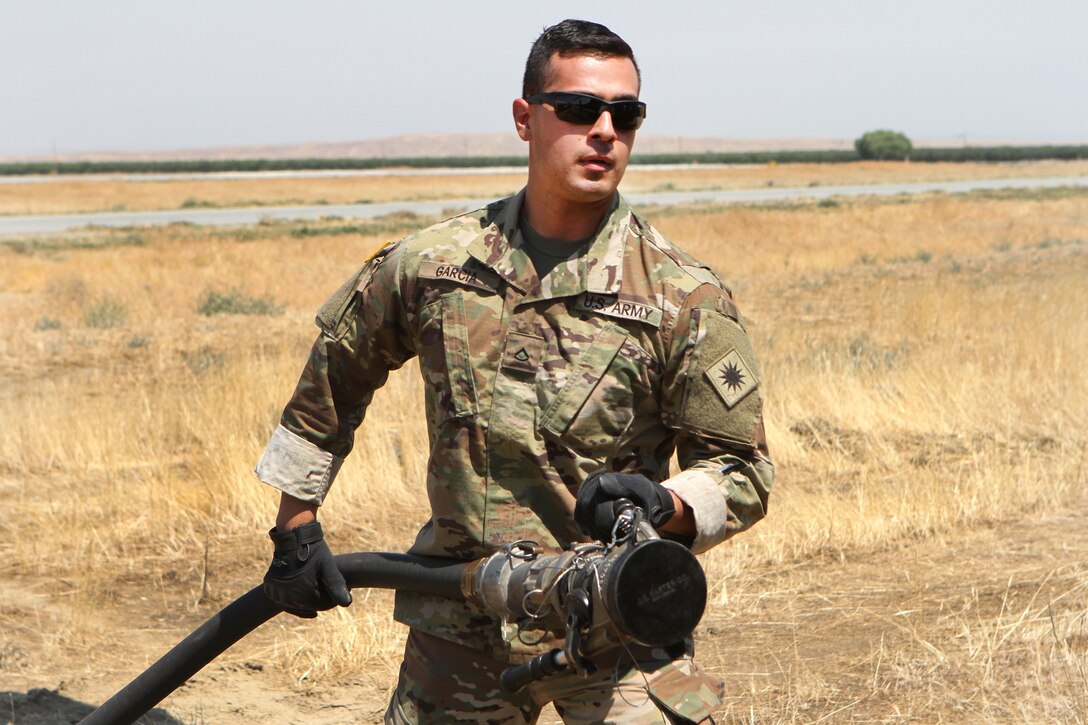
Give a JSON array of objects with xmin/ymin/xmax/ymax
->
[{"xmin": 419, "ymin": 292, "xmax": 479, "ymax": 425}]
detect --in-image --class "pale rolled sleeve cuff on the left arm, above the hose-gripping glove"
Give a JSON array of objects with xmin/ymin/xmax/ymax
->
[{"xmin": 254, "ymin": 426, "xmax": 344, "ymax": 506}]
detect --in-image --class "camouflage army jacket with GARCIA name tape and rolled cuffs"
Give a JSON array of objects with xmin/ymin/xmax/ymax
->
[{"xmin": 257, "ymin": 186, "xmax": 774, "ymax": 659}]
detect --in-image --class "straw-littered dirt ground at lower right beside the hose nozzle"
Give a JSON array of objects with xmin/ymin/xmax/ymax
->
[{"xmin": 703, "ymin": 496, "xmax": 1088, "ymax": 723}]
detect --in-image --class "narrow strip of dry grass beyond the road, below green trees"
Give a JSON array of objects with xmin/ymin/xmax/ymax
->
[{"xmin": 0, "ymin": 161, "xmax": 1088, "ymax": 214}]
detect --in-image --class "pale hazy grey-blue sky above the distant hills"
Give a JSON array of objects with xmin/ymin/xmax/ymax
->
[{"xmin": 0, "ymin": 0, "xmax": 1088, "ymax": 157}]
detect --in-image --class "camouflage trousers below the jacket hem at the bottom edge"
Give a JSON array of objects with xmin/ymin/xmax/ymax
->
[{"xmin": 385, "ymin": 629, "xmax": 724, "ymax": 725}]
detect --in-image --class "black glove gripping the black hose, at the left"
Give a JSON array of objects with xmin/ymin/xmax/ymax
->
[{"xmin": 264, "ymin": 521, "xmax": 351, "ymax": 619}]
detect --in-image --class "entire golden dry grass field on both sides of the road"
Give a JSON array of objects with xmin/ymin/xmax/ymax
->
[{"xmin": 0, "ymin": 164, "xmax": 1088, "ymax": 724}]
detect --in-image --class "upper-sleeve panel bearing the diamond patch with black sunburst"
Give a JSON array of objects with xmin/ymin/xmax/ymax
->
[{"xmin": 678, "ymin": 309, "xmax": 763, "ymax": 448}]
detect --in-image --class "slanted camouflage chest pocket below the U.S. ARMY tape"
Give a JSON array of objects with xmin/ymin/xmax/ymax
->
[{"xmin": 537, "ymin": 323, "xmax": 656, "ymax": 458}]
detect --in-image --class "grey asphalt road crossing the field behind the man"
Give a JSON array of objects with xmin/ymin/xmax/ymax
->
[{"xmin": 0, "ymin": 176, "xmax": 1088, "ymax": 235}]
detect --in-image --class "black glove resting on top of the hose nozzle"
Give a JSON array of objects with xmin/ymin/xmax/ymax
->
[{"xmin": 574, "ymin": 470, "xmax": 676, "ymax": 541}]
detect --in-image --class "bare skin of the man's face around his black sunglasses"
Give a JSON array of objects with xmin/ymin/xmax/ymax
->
[{"xmin": 514, "ymin": 54, "xmax": 639, "ymax": 204}]
